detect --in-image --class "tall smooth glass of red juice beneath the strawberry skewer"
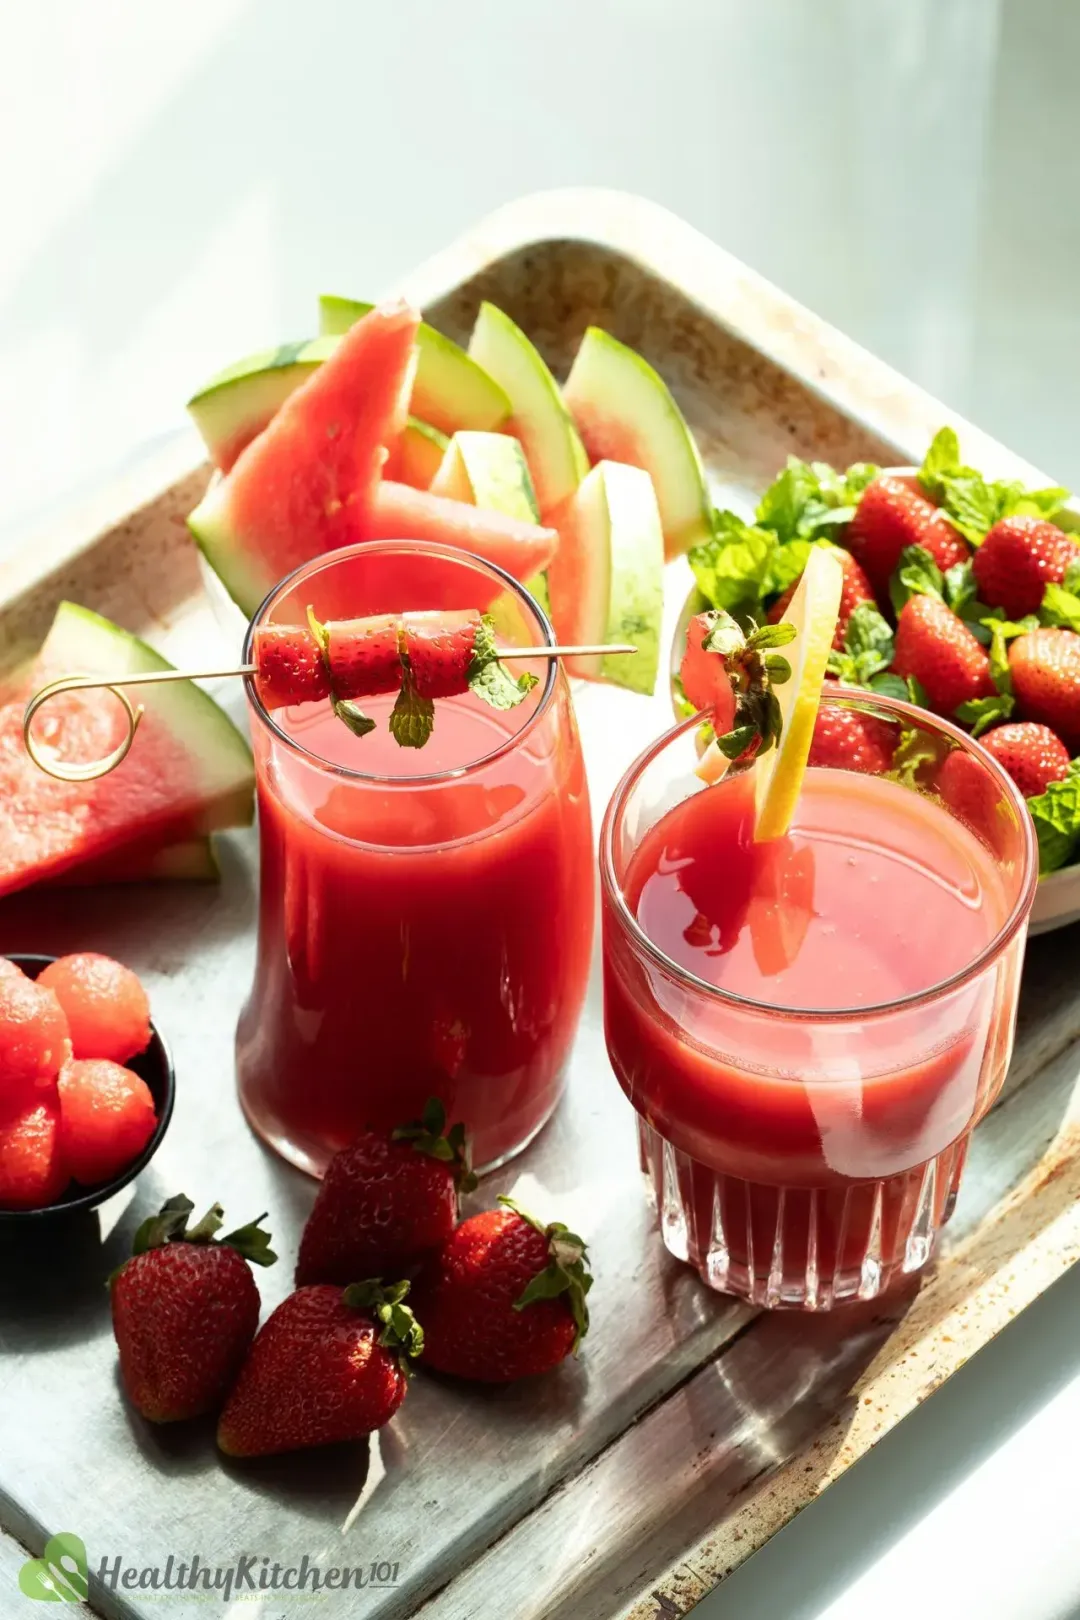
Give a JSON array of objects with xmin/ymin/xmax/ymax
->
[{"xmin": 236, "ymin": 541, "xmax": 594, "ymax": 1175}]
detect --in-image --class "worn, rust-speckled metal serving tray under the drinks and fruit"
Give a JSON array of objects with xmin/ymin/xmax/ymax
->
[{"xmin": 0, "ymin": 191, "xmax": 1080, "ymax": 1620}]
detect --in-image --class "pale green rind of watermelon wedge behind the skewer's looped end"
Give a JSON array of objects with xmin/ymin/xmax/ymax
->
[{"xmin": 42, "ymin": 601, "xmax": 254, "ymax": 833}]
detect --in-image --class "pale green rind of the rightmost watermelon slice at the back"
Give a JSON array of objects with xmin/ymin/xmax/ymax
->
[{"xmin": 562, "ymin": 326, "xmax": 711, "ymax": 557}]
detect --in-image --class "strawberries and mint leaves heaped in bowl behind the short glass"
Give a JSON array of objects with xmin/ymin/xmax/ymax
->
[{"xmin": 687, "ymin": 428, "xmax": 1080, "ymax": 870}]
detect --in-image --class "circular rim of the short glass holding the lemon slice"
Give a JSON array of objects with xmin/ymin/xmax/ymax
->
[{"xmin": 599, "ymin": 687, "xmax": 1038, "ymax": 1024}]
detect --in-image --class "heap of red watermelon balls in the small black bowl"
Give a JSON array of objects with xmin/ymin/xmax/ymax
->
[{"xmin": 0, "ymin": 951, "xmax": 157, "ymax": 1210}]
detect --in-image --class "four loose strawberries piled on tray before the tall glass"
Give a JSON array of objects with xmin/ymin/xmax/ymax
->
[{"xmin": 112, "ymin": 1100, "xmax": 593, "ymax": 1456}]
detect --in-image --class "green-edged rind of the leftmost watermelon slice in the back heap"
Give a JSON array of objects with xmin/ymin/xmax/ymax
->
[{"xmin": 188, "ymin": 337, "xmax": 337, "ymax": 467}]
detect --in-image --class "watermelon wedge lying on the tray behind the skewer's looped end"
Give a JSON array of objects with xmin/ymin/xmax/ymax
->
[{"xmin": 0, "ymin": 603, "xmax": 254, "ymax": 894}]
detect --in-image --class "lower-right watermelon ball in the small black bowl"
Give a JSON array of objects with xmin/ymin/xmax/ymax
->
[{"xmin": 60, "ymin": 1058, "xmax": 157, "ymax": 1187}]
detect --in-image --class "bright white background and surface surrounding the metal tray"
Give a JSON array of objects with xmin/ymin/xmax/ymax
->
[{"xmin": 0, "ymin": 0, "xmax": 1080, "ymax": 1620}]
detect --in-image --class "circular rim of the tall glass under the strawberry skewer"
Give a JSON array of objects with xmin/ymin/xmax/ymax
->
[{"xmin": 243, "ymin": 539, "xmax": 559, "ymax": 787}]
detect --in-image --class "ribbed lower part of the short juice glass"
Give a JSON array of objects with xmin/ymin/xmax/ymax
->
[{"xmin": 638, "ymin": 1116, "xmax": 968, "ymax": 1311}]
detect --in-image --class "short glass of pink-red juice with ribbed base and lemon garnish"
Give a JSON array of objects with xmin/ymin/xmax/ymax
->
[{"xmin": 601, "ymin": 689, "xmax": 1038, "ymax": 1309}]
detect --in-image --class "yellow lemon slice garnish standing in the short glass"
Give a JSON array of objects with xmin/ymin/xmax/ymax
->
[{"xmin": 753, "ymin": 546, "xmax": 844, "ymax": 844}]
